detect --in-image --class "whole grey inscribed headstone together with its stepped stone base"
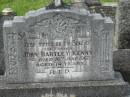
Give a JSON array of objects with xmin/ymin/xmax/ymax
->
[{"xmin": 0, "ymin": 0, "xmax": 130, "ymax": 97}]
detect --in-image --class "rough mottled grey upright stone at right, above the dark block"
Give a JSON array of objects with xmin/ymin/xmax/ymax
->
[{"xmin": 116, "ymin": 0, "xmax": 130, "ymax": 49}]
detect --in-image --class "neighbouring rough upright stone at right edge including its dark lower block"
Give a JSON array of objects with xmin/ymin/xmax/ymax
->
[{"xmin": 114, "ymin": 0, "xmax": 130, "ymax": 82}]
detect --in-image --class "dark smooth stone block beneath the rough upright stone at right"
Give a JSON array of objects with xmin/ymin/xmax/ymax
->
[{"xmin": 113, "ymin": 49, "xmax": 130, "ymax": 83}]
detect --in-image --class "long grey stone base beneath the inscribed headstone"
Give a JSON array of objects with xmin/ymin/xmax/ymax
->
[{"xmin": 0, "ymin": 80, "xmax": 130, "ymax": 97}]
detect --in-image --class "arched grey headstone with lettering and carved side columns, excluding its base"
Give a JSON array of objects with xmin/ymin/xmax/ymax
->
[{"xmin": 4, "ymin": 7, "xmax": 114, "ymax": 82}]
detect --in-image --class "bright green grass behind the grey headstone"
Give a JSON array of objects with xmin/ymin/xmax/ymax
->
[{"xmin": 0, "ymin": 0, "xmax": 117, "ymax": 15}]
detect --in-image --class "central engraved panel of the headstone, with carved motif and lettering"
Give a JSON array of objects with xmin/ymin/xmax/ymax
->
[{"xmin": 24, "ymin": 15, "xmax": 92, "ymax": 79}]
